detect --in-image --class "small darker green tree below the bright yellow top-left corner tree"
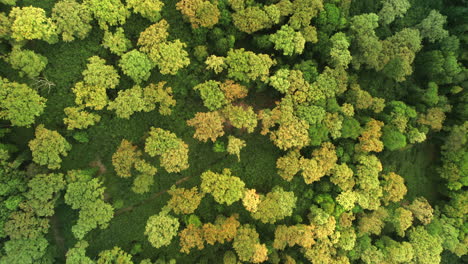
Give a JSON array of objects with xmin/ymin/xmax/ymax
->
[{"xmin": 7, "ymin": 48, "xmax": 48, "ymax": 78}]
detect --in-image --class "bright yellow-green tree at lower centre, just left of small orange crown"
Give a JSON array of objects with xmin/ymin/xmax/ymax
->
[{"xmin": 200, "ymin": 169, "xmax": 245, "ymax": 205}]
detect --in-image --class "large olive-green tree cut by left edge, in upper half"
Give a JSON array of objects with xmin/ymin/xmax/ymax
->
[{"xmin": 0, "ymin": 79, "xmax": 47, "ymax": 126}]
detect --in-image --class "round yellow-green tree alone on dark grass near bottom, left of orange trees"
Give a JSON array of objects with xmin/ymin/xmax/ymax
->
[{"xmin": 145, "ymin": 212, "xmax": 179, "ymax": 248}]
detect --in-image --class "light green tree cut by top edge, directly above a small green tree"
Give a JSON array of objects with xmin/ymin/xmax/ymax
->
[{"xmin": 83, "ymin": 0, "xmax": 130, "ymax": 30}]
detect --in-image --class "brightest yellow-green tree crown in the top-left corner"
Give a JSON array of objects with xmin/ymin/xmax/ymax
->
[{"xmin": 9, "ymin": 6, "xmax": 58, "ymax": 44}]
